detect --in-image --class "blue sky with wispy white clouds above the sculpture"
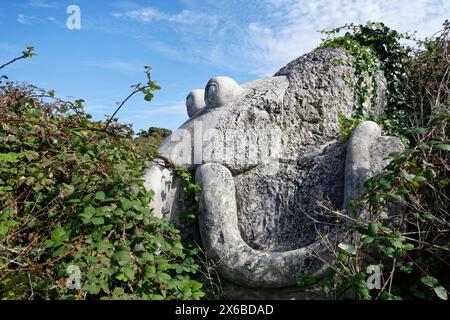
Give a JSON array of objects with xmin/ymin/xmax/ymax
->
[{"xmin": 0, "ymin": 0, "xmax": 450, "ymax": 130}]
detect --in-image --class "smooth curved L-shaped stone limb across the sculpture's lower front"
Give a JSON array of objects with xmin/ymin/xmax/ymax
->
[{"xmin": 196, "ymin": 163, "xmax": 328, "ymax": 288}]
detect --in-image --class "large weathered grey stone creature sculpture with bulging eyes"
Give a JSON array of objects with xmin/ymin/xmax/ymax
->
[{"xmin": 142, "ymin": 49, "xmax": 402, "ymax": 288}]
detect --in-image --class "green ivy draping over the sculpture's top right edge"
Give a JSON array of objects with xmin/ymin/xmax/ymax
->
[{"xmin": 320, "ymin": 22, "xmax": 411, "ymax": 126}]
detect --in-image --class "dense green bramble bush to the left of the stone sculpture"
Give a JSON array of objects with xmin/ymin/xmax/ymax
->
[{"xmin": 0, "ymin": 83, "xmax": 204, "ymax": 299}]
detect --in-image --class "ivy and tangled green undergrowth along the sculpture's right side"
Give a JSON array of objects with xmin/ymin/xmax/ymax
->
[{"xmin": 304, "ymin": 21, "xmax": 450, "ymax": 300}]
